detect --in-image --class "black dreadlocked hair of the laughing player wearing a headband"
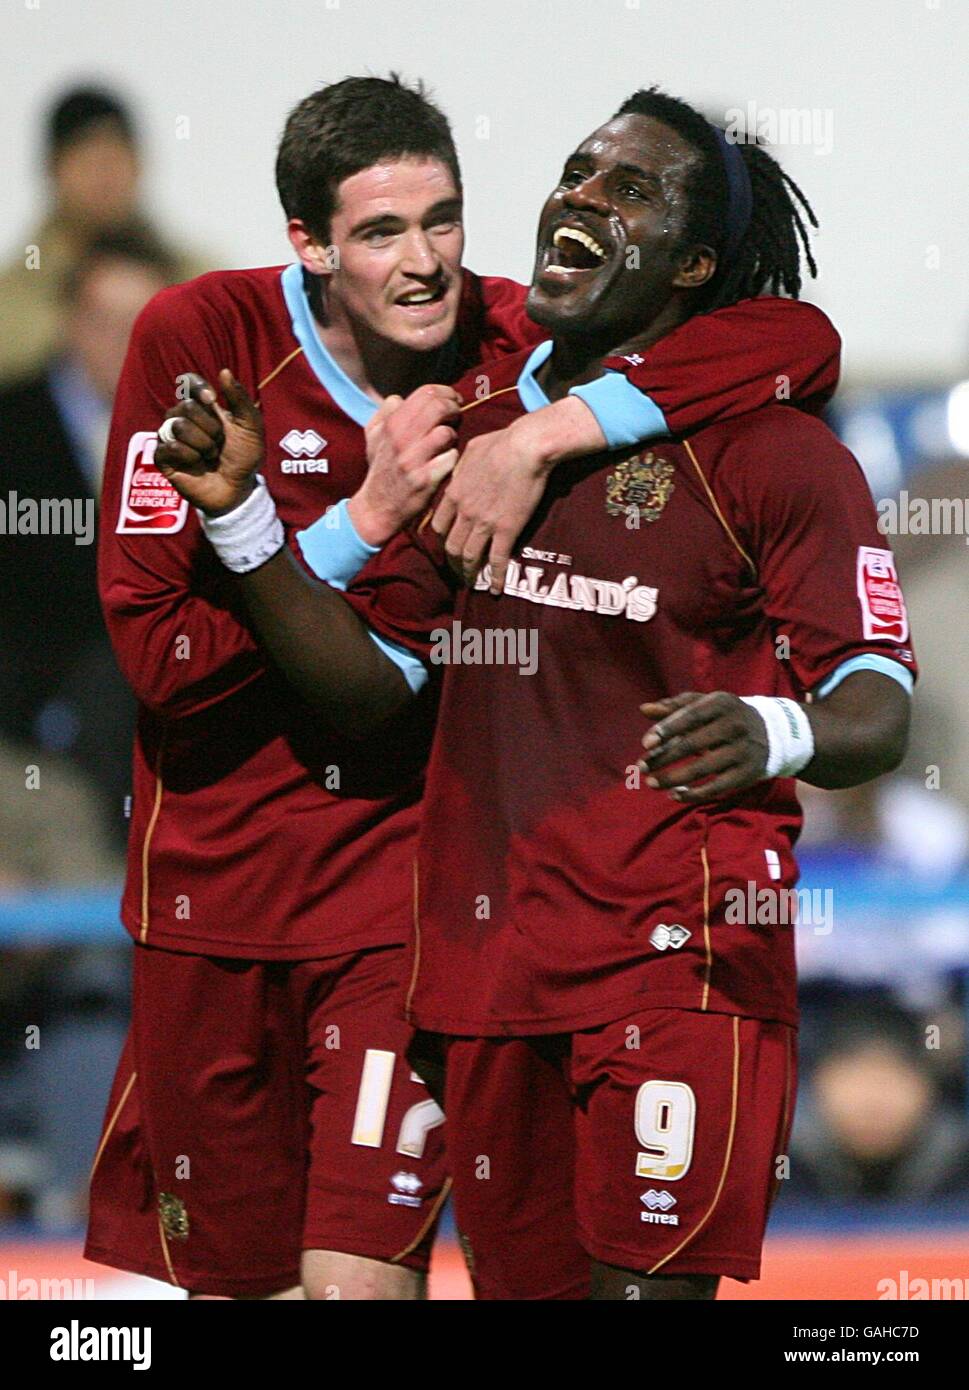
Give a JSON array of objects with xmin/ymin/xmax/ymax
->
[{"xmin": 616, "ymin": 88, "xmax": 817, "ymax": 313}]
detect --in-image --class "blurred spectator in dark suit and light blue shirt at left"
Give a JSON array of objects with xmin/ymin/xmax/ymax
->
[{"xmin": 0, "ymin": 231, "xmax": 174, "ymax": 844}]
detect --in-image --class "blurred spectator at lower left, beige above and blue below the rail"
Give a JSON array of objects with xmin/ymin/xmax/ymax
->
[{"xmin": 0, "ymin": 742, "xmax": 129, "ymax": 1226}]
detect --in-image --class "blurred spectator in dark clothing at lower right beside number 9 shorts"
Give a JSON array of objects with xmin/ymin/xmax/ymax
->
[{"xmin": 784, "ymin": 998, "xmax": 969, "ymax": 1201}]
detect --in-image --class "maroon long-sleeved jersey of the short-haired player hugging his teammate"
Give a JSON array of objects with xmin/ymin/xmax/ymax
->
[{"xmin": 99, "ymin": 265, "xmax": 840, "ymax": 959}]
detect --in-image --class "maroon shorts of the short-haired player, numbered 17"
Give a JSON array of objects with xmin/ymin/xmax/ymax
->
[{"xmin": 85, "ymin": 945, "xmax": 448, "ymax": 1297}]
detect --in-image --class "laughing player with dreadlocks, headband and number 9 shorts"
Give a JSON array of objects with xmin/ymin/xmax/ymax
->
[{"xmin": 155, "ymin": 92, "xmax": 915, "ymax": 1300}]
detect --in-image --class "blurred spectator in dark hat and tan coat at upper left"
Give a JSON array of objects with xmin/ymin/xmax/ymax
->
[{"xmin": 0, "ymin": 88, "xmax": 209, "ymax": 381}]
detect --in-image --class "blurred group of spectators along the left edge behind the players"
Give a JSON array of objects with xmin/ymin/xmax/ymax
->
[{"xmin": 0, "ymin": 86, "xmax": 213, "ymax": 1226}]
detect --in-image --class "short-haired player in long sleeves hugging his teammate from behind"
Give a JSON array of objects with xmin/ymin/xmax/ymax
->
[{"xmin": 86, "ymin": 79, "xmax": 837, "ymax": 1298}]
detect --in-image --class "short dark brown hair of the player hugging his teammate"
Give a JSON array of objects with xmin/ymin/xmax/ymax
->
[{"xmin": 275, "ymin": 72, "xmax": 462, "ymax": 238}]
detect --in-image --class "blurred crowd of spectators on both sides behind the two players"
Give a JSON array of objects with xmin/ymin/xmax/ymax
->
[{"xmin": 0, "ymin": 86, "xmax": 969, "ymax": 1230}]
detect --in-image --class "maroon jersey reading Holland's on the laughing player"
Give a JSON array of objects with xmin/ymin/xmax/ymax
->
[{"xmin": 348, "ymin": 344, "xmax": 913, "ymax": 1034}]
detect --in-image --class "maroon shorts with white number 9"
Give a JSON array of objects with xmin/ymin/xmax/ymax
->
[{"xmin": 442, "ymin": 1009, "xmax": 795, "ymax": 1298}]
